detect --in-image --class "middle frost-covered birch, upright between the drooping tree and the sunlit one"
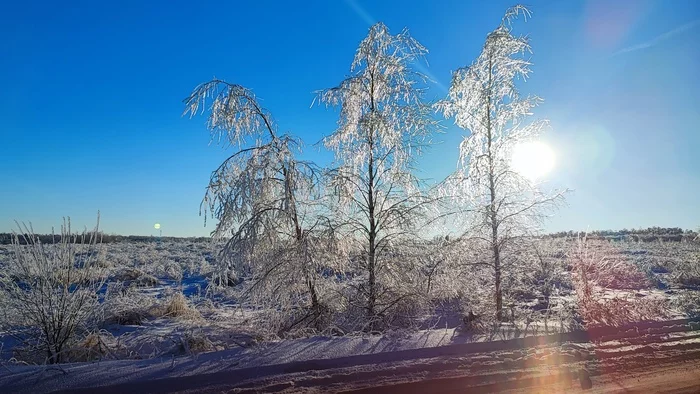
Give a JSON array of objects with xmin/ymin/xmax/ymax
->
[{"xmin": 319, "ymin": 23, "xmax": 436, "ymax": 321}]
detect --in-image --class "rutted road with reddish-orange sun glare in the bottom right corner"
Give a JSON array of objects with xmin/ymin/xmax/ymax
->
[{"xmin": 219, "ymin": 322, "xmax": 700, "ymax": 394}]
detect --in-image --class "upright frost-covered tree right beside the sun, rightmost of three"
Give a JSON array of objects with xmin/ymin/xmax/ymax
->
[{"xmin": 439, "ymin": 6, "xmax": 561, "ymax": 320}]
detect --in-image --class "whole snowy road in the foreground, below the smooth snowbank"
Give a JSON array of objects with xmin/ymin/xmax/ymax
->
[{"xmin": 9, "ymin": 320, "xmax": 700, "ymax": 394}]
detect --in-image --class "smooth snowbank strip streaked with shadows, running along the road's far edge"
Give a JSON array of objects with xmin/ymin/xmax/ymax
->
[{"xmin": 0, "ymin": 329, "xmax": 485, "ymax": 393}]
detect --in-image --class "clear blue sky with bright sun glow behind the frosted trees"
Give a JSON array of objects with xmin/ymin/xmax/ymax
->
[{"xmin": 0, "ymin": 0, "xmax": 700, "ymax": 236}]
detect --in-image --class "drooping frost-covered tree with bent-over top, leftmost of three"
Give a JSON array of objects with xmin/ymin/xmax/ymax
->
[{"xmin": 185, "ymin": 79, "xmax": 333, "ymax": 328}]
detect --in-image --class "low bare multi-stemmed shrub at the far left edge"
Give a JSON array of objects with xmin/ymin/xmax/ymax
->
[{"xmin": 0, "ymin": 216, "xmax": 105, "ymax": 364}]
